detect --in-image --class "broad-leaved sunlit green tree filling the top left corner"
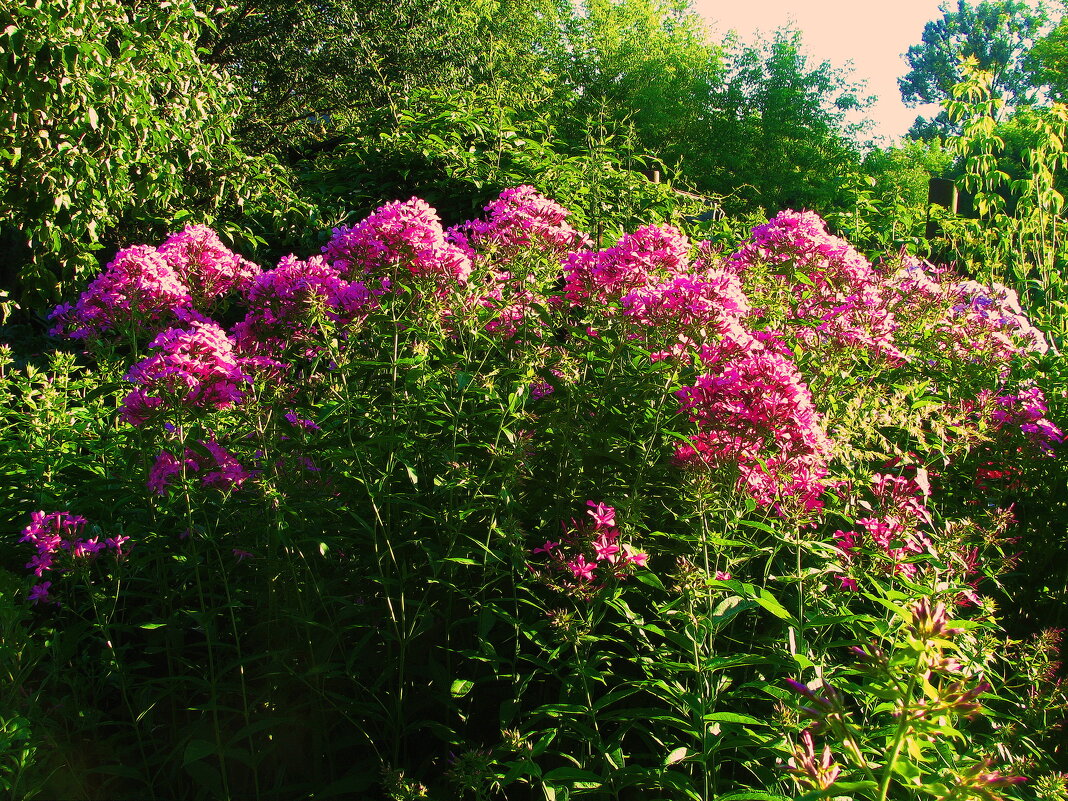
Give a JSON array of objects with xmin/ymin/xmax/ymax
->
[{"xmin": 0, "ymin": 0, "xmax": 310, "ymax": 299}]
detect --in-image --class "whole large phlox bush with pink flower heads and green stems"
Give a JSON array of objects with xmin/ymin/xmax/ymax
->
[{"xmin": 0, "ymin": 186, "xmax": 1068, "ymax": 801}]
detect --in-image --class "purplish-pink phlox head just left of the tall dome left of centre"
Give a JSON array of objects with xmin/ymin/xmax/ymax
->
[{"xmin": 234, "ymin": 255, "xmax": 378, "ymax": 355}]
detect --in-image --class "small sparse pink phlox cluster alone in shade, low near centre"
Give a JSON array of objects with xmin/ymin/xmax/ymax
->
[{"xmin": 530, "ymin": 501, "xmax": 648, "ymax": 597}]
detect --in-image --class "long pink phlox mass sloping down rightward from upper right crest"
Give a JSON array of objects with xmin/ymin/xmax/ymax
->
[{"xmin": 728, "ymin": 210, "xmax": 902, "ymax": 360}]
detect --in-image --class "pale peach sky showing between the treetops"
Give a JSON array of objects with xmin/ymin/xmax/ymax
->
[{"xmin": 693, "ymin": 0, "xmax": 957, "ymax": 143}]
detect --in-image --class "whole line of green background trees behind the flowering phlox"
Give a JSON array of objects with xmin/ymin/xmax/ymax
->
[{"xmin": 6, "ymin": 0, "xmax": 1068, "ymax": 302}]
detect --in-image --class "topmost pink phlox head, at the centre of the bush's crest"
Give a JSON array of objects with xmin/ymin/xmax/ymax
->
[{"xmin": 446, "ymin": 185, "xmax": 591, "ymax": 264}]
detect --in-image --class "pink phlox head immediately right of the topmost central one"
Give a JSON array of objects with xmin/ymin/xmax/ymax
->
[{"xmin": 563, "ymin": 225, "xmax": 690, "ymax": 305}]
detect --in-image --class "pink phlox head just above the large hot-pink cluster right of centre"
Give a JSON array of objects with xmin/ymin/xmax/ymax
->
[{"xmin": 622, "ymin": 268, "xmax": 752, "ymax": 363}]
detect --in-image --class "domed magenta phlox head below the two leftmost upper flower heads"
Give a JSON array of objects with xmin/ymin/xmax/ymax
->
[{"xmin": 121, "ymin": 321, "xmax": 251, "ymax": 425}]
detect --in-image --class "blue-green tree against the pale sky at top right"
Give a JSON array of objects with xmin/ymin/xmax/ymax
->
[{"xmin": 897, "ymin": 0, "xmax": 1047, "ymax": 139}]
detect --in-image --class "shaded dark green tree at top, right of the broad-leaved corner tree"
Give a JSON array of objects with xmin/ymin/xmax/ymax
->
[{"xmin": 200, "ymin": 0, "xmax": 489, "ymax": 161}]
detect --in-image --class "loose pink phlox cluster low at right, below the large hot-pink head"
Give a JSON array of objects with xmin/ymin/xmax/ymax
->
[{"xmin": 834, "ymin": 473, "xmax": 937, "ymax": 591}]
